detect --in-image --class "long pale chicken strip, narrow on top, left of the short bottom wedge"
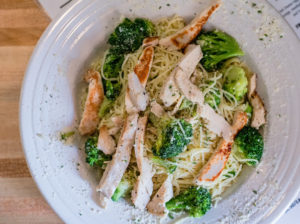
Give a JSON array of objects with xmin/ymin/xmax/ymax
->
[{"xmin": 131, "ymin": 116, "xmax": 154, "ymax": 209}]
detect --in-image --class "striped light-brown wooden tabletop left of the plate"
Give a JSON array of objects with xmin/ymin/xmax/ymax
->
[{"xmin": 0, "ymin": 0, "xmax": 62, "ymax": 224}]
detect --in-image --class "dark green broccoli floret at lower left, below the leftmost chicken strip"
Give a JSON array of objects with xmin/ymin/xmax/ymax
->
[{"xmin": 85, "ymin": 136, "xmax": 111, "ymax": 168}]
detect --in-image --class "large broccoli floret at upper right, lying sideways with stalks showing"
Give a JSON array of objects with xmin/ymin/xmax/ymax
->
[{"xmin": 197, "ymin": 30, "xmax": 244, "ymax": 71}]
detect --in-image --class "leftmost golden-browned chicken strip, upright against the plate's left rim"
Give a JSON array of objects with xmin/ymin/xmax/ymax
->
[{"xmin": 79, "ymin": 69, "xmax": 104, "ymax": 135}]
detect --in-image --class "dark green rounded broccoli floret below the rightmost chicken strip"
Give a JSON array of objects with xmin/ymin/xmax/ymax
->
[{"xmin": 234, "ymin": 126, "xmax": 264, "ymax": 166}]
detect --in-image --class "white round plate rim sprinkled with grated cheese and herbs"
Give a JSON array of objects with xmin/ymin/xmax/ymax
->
[{"xmin": 20, "ymin": 0, "xmax": 300, "ymax": 224}]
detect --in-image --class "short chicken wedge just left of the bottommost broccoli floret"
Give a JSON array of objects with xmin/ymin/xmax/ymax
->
[{"xmin": 147, "ymin": 175, "xmax": 173, "ymax": 216}]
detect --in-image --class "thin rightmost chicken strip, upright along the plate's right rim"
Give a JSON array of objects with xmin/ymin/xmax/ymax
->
[{"xmin": 248, "ymin": 74, "xmax": 266, "ymax": 129}]
